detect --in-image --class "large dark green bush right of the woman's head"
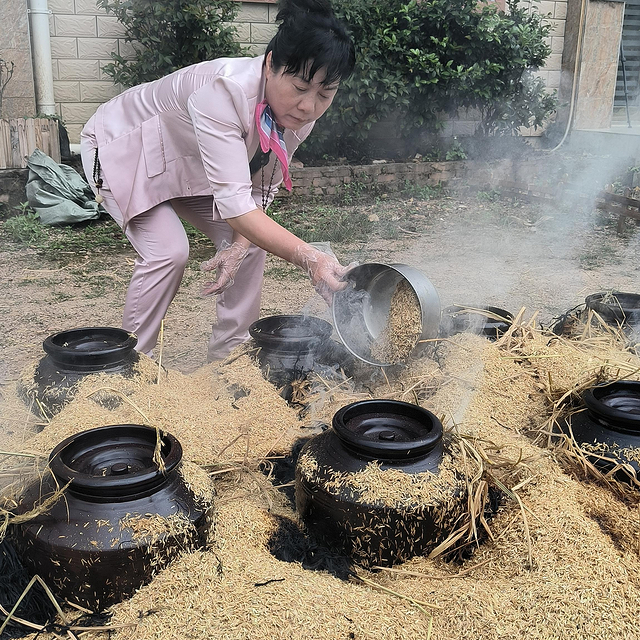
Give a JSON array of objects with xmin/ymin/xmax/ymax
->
[{"xmin": 305, "ymin": 0, "xmax": 556, "ymax": 157}]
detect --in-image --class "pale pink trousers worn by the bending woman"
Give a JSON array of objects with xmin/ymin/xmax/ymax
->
[{"xmin": 81, "ymin": 135, "xmax": 266, "ymax": 361}]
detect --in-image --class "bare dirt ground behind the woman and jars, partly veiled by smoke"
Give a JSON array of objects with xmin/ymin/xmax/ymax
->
[{"xmin": 0, "ymin": 194, "xmax": 640, "ymax": 384}]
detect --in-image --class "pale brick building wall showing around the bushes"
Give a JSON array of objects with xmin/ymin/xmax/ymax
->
[{"xmin": 45, "ymin": 0, "xmax": 567, "ymax": 143}]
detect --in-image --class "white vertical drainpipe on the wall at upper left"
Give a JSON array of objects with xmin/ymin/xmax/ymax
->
[{"xmin": 27, "ymin": 0, "xmax": 56, "ymax": 115}]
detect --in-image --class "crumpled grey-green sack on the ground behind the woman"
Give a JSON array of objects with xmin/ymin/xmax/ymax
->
[{"xmin": 27, "ymin": 149, "xmax": 102, "ymax": 225}]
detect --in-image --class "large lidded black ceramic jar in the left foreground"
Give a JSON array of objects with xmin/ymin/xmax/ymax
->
[{"xmin": 13, "ymin": 424, "xmax": 211, "ymax": 611}]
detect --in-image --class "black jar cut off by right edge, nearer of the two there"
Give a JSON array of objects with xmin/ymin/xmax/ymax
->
[{"xmin": 563, "ymin": 380, "xmax": 640, "ymax": 481}]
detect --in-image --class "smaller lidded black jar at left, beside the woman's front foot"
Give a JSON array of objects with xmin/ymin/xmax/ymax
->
[{"xmin": 20, "ymin": 327, "xmax": 139, "ymax": 417}]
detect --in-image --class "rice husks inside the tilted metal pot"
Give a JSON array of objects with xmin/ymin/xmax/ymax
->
[{"xmin": 371, "ymin": 280, "xmax": 422, "ymax": 363}]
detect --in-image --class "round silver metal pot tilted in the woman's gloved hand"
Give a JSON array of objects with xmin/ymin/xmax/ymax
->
[{"xmin": 331, "ymin": 262, "xmax": 440, "ymax": 367}]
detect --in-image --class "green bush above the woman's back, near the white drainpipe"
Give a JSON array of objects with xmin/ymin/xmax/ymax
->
[{"xmin": 97, "ymin": 0, "xmax": 242, "ymax": 87}]
